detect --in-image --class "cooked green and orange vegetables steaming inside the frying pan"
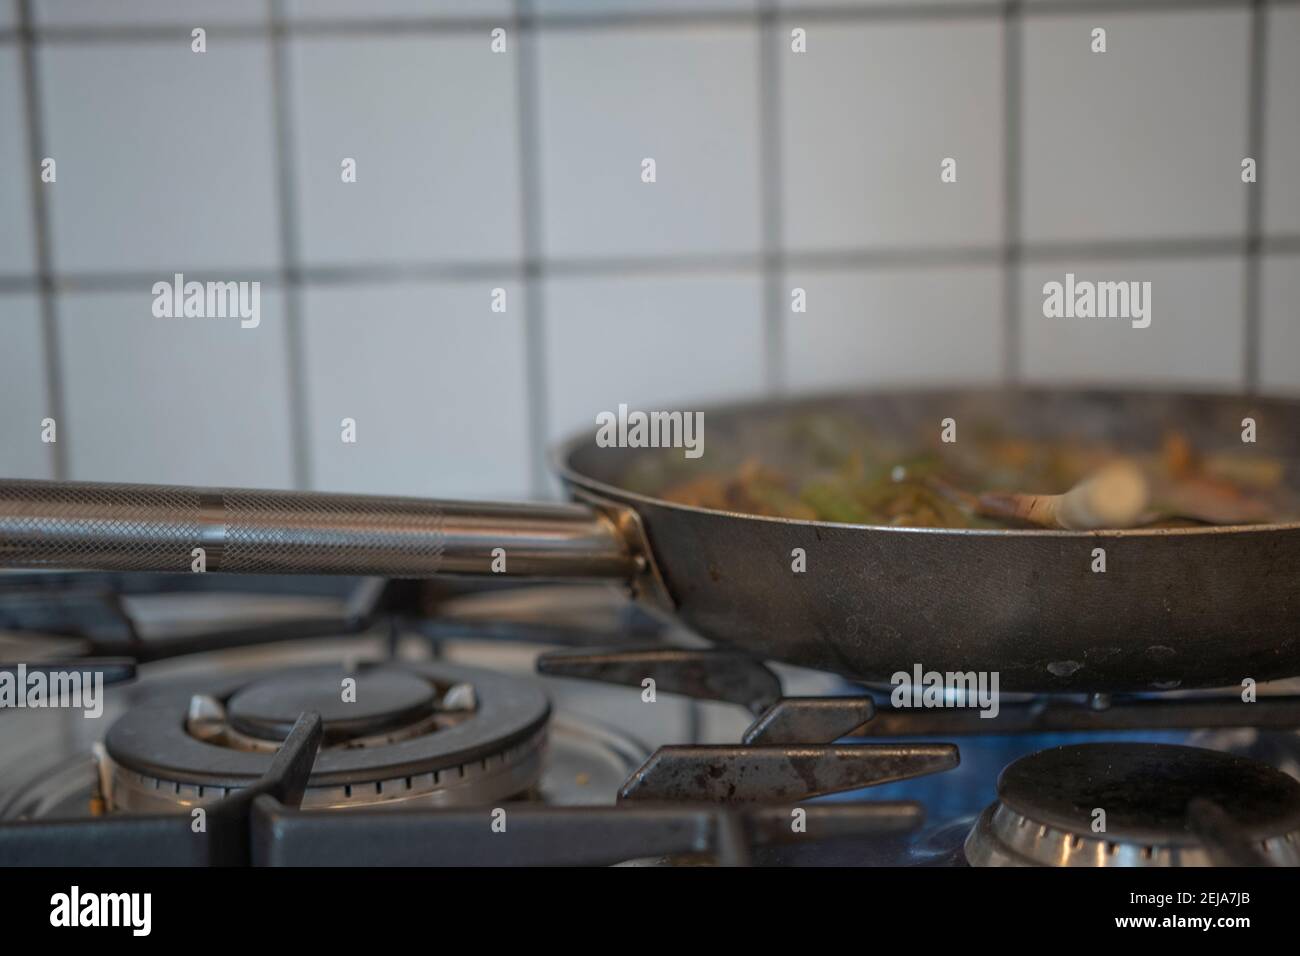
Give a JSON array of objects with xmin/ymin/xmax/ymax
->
[{"xmin": 650, "ymin": 414, "xmax": 1296, "ymax": 529}]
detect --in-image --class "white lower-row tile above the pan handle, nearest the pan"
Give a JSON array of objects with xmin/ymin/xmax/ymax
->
[{"xmin": 303, "ymin": 280, "xmax": 530, "ymax": 498}]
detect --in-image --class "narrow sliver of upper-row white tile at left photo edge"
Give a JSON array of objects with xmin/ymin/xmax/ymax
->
[{"xmin": 0, "ymin": 44, "xmax": 36, "ymax": 274}]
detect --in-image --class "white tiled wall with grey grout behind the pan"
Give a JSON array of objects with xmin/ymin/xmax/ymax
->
[{"xmin": 0, "ymin": 0, "xmax": 1300, "ymax": 497}]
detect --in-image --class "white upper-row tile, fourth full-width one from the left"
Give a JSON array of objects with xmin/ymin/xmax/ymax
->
[{"xmin": 780, "ymin": 18, "xmax": 1004, "ymax": 251}]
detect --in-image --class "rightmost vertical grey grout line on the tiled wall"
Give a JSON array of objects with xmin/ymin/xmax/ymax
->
[{"xmin": 1242, "ymin": 0, "xmax": 1273, "ymax": 394}]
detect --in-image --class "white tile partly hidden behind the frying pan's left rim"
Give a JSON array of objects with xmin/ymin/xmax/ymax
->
[{"xmin": 546, "ymin": 269, "xmax": 763, "ymax": 440}]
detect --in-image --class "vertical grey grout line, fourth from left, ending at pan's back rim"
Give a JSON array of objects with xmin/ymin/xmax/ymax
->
[{"xmin": 758, "ymin": 0, "xmax": 789, "ymax": 394}]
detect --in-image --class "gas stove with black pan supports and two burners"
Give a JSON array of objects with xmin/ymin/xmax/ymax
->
[{"xmin": 0, "ymin": 574, "xmax": 1300, "ymax": 868}]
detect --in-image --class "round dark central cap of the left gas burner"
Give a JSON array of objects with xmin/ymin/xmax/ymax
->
[{"xmin": 226, "ymin": 669, "xmax": 436, "ymax": 743}]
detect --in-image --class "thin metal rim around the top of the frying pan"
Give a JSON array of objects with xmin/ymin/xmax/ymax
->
[{"xmin": 550, "ymin": 385, "xmax": 1300, "ymax": 540}]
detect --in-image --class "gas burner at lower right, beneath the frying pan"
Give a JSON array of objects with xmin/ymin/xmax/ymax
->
[{"xmin": 966, "ymin": 743, "xmax": 1300, "ymax": 866}]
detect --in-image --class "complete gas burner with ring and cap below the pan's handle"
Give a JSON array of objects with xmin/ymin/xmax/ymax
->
[{"xmin": 101, "ymin": 662, "xmax": 550, "ymax": 812}]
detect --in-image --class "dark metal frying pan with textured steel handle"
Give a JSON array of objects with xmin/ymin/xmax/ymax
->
[{"xmin": 0, "ymin": 390, "xmax": 1300, "ymax": 692}]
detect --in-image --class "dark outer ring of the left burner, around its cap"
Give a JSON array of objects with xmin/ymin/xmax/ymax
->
[{"xmin": 104, "ymin": 662, "xmax": 550, "ymax": 809}]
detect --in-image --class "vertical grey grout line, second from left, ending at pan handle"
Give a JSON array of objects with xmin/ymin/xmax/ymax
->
[{"xmin": 267, "ymin": 0, "xmax": 315, "ymax": 489}]
